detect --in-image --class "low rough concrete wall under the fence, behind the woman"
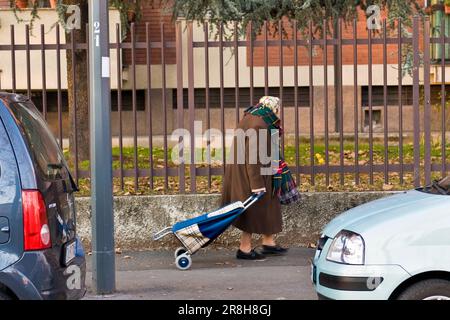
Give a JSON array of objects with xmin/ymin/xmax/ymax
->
[{"xmin": 76, "ymin": 192, "xmax": 393, "ymax": 250}]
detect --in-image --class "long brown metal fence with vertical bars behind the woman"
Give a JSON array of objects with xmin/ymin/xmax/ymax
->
[{"xmin": 0, "ymin": 17, "xmax": 450, "ymax": 193}]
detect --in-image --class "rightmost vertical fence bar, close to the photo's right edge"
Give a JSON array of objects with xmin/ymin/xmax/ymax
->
[{"xmin": 440, "ymin": 16, "xmax": 447, "ymax": 177}]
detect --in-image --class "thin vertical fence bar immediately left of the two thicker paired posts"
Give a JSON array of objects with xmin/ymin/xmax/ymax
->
[{"xmin": 161, "ymin": 22, "xmax": 169, "ymax": 191}]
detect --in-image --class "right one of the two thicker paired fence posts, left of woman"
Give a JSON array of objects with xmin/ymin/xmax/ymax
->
[{"xmin": 187, "ymin": 22, "xmax": 195, "ymax": 193}]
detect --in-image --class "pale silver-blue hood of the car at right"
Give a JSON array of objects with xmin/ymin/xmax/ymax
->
[{"xmin": 323, "ymin": 190, "xmax": 450, "ymax": 238}]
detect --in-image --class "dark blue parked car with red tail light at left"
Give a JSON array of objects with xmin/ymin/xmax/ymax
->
[{"xmin": 0, "ymin": 93, "xmax": 86, "ymax": 300}]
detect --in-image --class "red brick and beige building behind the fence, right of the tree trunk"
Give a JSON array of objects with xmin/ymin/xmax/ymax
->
[{"xmin": 0, "ymin": 0, "xmax": 450, "ymax": 136}]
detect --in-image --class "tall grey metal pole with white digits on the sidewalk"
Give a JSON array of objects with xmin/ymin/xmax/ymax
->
[{"xmin": 89, "ymin": 0, "xmax": 115, "ymax": 294}]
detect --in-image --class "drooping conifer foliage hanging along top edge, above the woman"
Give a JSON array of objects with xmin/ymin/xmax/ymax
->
[{"xmin": 168, "ymin": 0, "xmax": 422, "ymax": 37}]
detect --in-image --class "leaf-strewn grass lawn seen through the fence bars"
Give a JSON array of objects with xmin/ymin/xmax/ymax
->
[{"xmin": 65, "ymin": 141, "xmax": 450, "ymax": 195}]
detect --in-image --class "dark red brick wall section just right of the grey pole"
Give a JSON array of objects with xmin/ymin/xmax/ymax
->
[{"xmin": 124, "ymin": 5, "xmax": 176, "ymax": 65}]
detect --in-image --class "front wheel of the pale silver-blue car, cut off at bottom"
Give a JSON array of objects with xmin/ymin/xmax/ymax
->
[{"xmin": 397, "ymin": 279, "xmax": 450, "ymax": 300}]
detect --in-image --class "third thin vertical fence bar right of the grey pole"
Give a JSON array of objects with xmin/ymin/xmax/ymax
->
[{"xmin": 145, "ymin": 22, "xmax": 153, "ymax": 190}]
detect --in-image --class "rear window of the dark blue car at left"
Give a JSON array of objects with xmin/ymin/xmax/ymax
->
[{"xmin": 11, "ymin": 102, "xmax": 66, "ymax": 180}]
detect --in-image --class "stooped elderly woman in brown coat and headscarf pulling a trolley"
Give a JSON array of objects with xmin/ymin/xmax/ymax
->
[{"xmin": 222, "ymin": 97, "xmax": 287, "ymax": 260}]
